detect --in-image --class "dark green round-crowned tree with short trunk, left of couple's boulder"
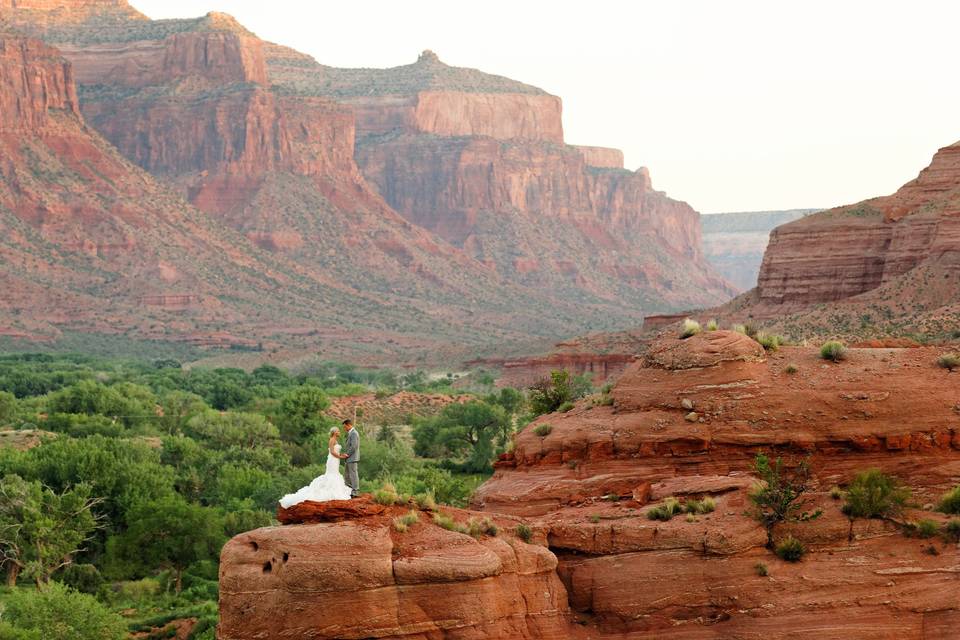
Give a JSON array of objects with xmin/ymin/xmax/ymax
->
[{"xmin": 107, "ymin": 495, "xmax": 226, "ymax": 594}]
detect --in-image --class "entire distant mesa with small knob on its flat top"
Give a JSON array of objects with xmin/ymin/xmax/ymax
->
[{"xmin": 267, "ymin": 47, "xmax": 731, "ymax": 309}]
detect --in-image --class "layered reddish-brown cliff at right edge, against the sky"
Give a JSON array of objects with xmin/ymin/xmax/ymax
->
[{"xmin": 757, "ymin": 143, "xmax": 960, "ymax": 306}]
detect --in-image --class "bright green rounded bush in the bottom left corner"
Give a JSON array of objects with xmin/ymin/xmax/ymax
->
[{"xmin": 0, "ymin": 582, "xmax": 127, "ymax": 640}]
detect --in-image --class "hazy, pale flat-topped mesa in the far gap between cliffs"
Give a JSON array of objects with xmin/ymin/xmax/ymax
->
[{"xmin": 700, "ymin": 209, "xmax": 817, "ymax": 291}]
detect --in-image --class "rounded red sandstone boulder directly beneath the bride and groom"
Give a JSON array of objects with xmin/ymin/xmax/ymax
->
[{"xmin": 218, "ymin": 500, "xmax": 568, "ymax": 640}]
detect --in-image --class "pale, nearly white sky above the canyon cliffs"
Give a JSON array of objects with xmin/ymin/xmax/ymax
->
[{"xmin": 131, "ymin": 0, "xmax": 960, "ymax": 212}]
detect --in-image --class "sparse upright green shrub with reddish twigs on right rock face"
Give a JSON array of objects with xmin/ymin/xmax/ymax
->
[{"xmin": 750, "ymin": 453, "xmax": 823, "ymax": 548}]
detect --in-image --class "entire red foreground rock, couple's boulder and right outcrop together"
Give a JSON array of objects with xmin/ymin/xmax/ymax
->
[{"xmin": 219, "ymin": 331, "xmax": 960, "ymax": 640}]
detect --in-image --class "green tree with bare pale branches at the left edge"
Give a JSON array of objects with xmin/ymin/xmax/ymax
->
[{"xmin": 0, "ymin": 475, "xmax": 99, "ymax": 587}]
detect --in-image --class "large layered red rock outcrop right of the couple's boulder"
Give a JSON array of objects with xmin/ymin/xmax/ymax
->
[{"xmin": 474, "ymin": 332, "xmax": 960, "ymax": 639}]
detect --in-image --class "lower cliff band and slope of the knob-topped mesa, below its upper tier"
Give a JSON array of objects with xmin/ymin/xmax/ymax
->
[{"xmin": 357, "ymin": 135, "xmax": 731, "ymax": 307}]
